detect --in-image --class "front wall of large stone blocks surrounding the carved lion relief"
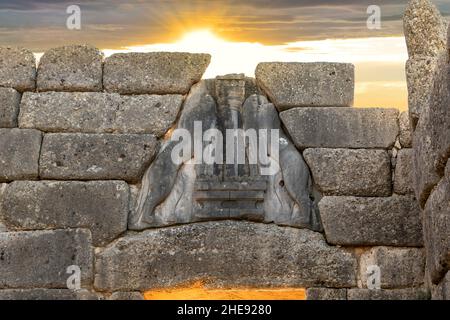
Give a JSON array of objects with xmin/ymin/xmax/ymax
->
[{"xmin": 0, "ymin": 46, "xmax": 428, "ymax": 299}]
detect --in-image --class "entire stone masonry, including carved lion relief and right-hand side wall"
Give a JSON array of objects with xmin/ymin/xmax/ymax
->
[{"xmin": 0, "ymin": 1, "xmax": 450, "ymax": 299}]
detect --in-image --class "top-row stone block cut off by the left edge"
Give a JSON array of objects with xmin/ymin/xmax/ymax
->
[{"xmin": 0, "ymin": 46, "xmax": 36, "ymax": 92}]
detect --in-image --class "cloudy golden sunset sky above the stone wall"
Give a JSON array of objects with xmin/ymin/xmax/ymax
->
[{"xmin": 0, "ymin": 0, "xmax": 450, "ymax": 109}]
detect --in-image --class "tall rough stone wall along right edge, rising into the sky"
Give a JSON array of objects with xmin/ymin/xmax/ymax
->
[{"xmin": 404, "ymin": 0, "xmax": 450, "ymax": 299}]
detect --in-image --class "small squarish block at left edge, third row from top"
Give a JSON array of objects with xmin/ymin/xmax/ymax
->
[{"xmin": 0, "ymin": 129, "xmax": 42, "ymax": 182}]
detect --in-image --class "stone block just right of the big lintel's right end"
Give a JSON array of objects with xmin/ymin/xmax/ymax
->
[{"xmin": 359, "ymin": 247, "xmax": 425, "ymax": 289}]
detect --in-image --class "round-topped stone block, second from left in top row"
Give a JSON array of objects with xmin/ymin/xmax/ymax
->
[{"xmin": 37, "ymin": 45, "xmax": 103, "ymax": 91}]
